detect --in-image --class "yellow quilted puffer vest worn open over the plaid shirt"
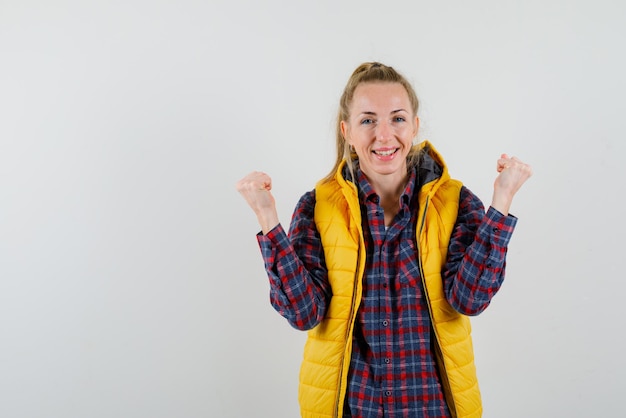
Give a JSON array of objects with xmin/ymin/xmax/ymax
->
[{"xmin": 299, "ymin": 142, "xmax": 482, "ymax": 418}]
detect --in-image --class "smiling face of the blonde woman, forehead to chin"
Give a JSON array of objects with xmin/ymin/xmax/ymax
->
[{"xmin": 341, "ymin": 83, "xmax": 419, "ymax": 181}]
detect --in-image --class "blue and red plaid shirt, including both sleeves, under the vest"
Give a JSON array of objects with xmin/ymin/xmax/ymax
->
[{"xmin": 257, "ymin": 165, "xmax": 517, "ymax": 417}]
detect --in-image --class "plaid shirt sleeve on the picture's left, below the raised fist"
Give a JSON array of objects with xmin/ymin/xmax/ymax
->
[{"xmin": 257, "ymin": 191, "xmax": 332, "ymax": 330}]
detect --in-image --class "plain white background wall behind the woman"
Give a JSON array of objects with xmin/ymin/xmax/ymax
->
[{"xmin": 0, "ymin": 0, "xmax": 626, "ymax": 418}]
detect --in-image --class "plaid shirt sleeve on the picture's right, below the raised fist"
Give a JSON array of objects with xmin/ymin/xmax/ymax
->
[{"xmin": 442, "ymin": 187, "xmax": 517, "ymax": 315}]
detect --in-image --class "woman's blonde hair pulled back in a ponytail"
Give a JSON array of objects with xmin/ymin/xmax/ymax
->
[{"xmin": 322, "ymin": 62, "xmax": 420, "ymax": 182}]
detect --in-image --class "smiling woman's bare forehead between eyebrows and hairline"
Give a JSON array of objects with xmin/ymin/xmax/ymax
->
[{"xmin": 350, "ymin": 82, "xmax": 412, "ymax": 112}]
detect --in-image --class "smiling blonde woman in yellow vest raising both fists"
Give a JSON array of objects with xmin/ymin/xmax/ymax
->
[{"xmin": 237, "ymin": 63, "xmax": 531, "ymax": 417}]
